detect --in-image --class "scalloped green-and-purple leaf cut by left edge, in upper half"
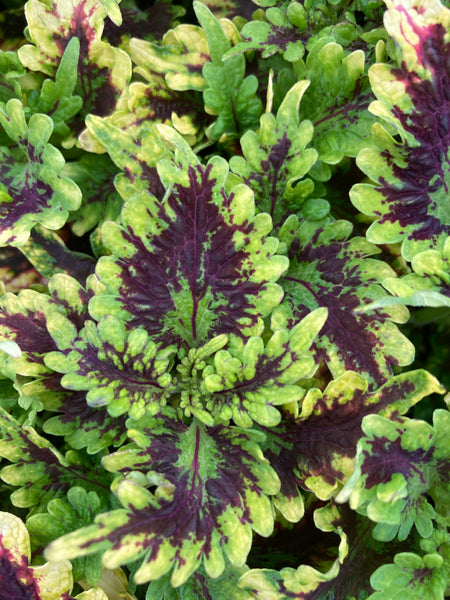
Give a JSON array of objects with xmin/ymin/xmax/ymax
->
[{"xmin": 0, "ymin": 98, "xmax": 81, "ymax": 246}]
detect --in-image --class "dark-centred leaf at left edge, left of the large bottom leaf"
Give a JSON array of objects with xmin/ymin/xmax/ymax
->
[{"xmin": 0, "ymin": 408, "xmax": 109, "ymax": 510}]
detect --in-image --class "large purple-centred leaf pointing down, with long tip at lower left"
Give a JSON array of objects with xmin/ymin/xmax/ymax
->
[{"xmin": 46, "ymin": 409, "xmax": 279, "ymax": 587}]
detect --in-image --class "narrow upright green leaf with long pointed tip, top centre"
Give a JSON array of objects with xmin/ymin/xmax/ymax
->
[{"xmin": 194, "ymin": 2, "xmax": 262, "ymax": 140}]
